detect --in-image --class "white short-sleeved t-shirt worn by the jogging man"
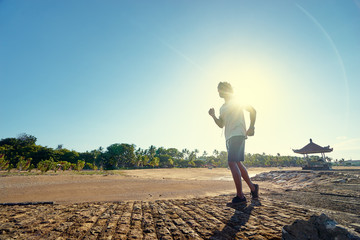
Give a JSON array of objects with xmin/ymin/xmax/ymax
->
[{"xmin": 220, "ymin": 100, "xmax": 246, "ymax": 140}]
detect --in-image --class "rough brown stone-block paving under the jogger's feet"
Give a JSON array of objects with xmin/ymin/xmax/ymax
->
[{"xmin": 0, "ymin": 195, "xmax": 317, "ymax": 239}]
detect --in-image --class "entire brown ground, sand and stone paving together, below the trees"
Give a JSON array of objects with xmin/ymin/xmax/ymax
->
[{"xmin": 0, "ymin": 168, "xmax": 360, "ymax": 240}]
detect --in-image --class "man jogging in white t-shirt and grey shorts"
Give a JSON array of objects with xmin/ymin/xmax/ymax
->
[{"xmin": 209, "ymin": 82, "xmax": 259, "ymax": 203}]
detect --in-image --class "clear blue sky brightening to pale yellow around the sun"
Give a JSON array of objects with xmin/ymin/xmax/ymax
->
[{"xmin": 0, "ymin": 0, "xmax": 360, "ymax": 160}]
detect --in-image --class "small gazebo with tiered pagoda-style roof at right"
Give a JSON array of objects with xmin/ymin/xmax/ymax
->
[{"xmin": 293, "ymin": 138, "xmax": 333, "ymax": 170}]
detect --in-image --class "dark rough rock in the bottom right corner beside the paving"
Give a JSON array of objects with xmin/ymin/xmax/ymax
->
[{"xmin": 282, "ymin": 214, "xmax": 360, "ymax": 240}]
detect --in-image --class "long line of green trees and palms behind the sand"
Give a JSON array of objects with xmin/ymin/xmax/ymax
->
[{"xmin": 0, "ymin": 133, "xmax": 310, "ymax": 172}]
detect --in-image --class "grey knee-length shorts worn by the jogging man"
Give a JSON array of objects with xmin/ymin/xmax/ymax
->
[{"xmin": 226, "ymin": 136, "xmax": 245, "ymax": 162}]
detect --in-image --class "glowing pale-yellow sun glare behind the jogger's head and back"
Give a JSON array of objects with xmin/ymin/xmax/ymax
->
[{"xmin": 202, "ymin": 56, "xmax": 282, "ymax": 139}]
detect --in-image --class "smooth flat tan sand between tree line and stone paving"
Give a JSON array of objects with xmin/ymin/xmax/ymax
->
[{"xmin": 0, "ymin": 168, "xmax": 299, "ymax": 203}]
